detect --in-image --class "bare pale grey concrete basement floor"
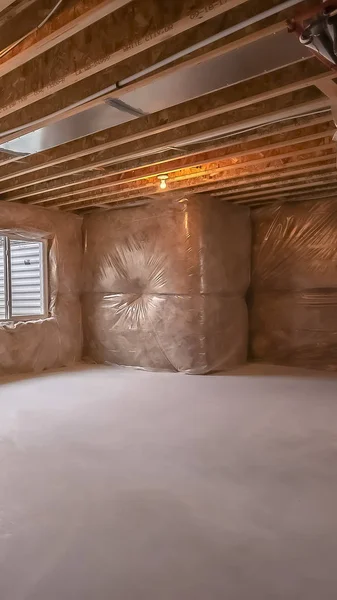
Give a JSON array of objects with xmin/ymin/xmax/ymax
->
[{"xmin": 0, "ymin": 367, "xmax": 337, "ymax": 600}]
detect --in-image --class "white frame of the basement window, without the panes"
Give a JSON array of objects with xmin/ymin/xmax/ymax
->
[{"xmin": 0, "ymin": 230, "xmax": 49, "ymax": 323}]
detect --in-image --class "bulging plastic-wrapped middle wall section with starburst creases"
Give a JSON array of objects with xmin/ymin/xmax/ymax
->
[{"xmin": 83, "ymin": 198, "xmax": 250, "ymax": 373}]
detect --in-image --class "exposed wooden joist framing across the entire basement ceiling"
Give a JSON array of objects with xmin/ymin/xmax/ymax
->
[{"xmin": 0, "ymin": 0, "xmax": 337, "ymax": 214}]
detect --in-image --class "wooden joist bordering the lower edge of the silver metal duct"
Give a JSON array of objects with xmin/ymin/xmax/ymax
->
[{"xmin": 0, "ymin": 58, "xmax": 333, "ymax": 174}]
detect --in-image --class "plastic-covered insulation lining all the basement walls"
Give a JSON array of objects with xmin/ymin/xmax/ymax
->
[{"xmin": 0, "ymin": 197, "xmax": 337, "ymax": 374}]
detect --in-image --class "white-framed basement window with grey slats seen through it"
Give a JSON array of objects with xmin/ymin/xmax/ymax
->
[{"xmin": 0, "ymin": 234, "xmax": 48, "ymax": 321}]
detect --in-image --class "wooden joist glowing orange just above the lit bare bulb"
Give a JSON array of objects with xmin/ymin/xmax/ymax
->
[{"xmin": 6, "ymin": 123, "xmax": 334, "ymax": 203}]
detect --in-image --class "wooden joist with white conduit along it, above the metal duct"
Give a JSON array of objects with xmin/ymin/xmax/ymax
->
[{"xmin": 0, "ymin": 0, "xmax": 311, "ymax": 142}]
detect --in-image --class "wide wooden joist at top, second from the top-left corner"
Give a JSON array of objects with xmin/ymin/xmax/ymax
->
[{"xmin": 0, "ymin": 0, "xmax": 246, "ymax": 118}]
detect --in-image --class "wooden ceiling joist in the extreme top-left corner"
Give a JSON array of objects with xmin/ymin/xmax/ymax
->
[{"xmin": 0, "ymin": 0, "xmax": 132, "ymax": 77}]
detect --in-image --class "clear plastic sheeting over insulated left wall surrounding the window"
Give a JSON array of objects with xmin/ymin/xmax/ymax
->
[{"xmin": 0, "ymin": 202, "xmax": 82, "ymax": 374}]
